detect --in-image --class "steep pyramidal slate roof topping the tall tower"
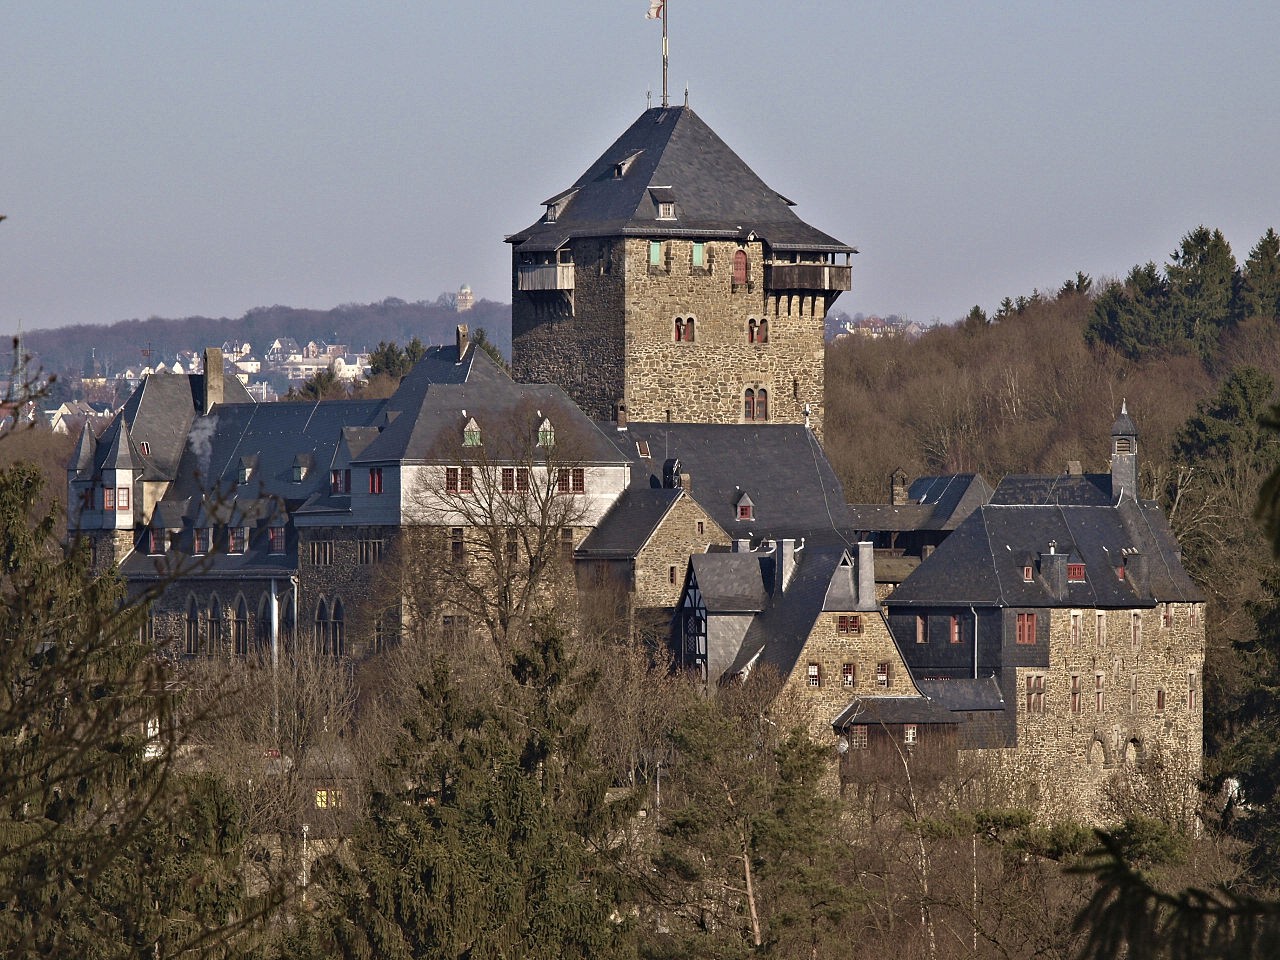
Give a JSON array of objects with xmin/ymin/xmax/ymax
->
[{"xmin": 507, "ymin": 106, "xmax": 856, "ymax": 253}]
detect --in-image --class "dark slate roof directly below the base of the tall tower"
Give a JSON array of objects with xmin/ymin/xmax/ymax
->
[{"xmin": 607, "ymin": 422, "xmax": 854, "ymax": 547}]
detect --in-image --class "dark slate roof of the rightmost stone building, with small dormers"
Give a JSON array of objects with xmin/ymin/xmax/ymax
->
[{"xmin": 890, "ymin": 499, "xmax": 1204, "ymax": 608}]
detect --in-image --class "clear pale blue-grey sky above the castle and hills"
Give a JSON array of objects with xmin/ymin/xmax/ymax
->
[{"xmin": 0, "ymin": 0, "xmax": 1280, "ymax": 330}]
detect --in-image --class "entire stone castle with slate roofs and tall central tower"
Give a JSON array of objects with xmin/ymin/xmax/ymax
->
[{"xmin": 68, "ymin": 105, "xmax": 1204, "ymax": 819}]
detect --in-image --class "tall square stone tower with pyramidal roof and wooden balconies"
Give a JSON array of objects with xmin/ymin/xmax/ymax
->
[{"xmin": 507, "ymin": 106, "xmax": 858, "ymax": 434}]
